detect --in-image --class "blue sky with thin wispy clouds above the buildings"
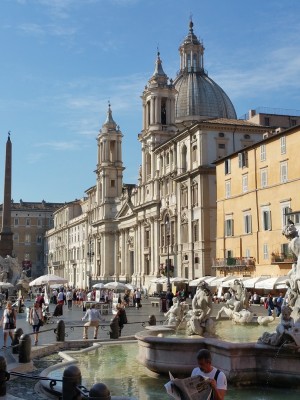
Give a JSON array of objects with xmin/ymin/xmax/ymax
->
[{"xmin": 0, "ymin": 0, "xmax": 300, "ymax": 202}]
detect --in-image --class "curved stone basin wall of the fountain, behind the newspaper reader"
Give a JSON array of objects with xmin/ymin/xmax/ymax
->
[{"xmin": 135, "ymin": 330, "xmax": 300, "ymax": 388}]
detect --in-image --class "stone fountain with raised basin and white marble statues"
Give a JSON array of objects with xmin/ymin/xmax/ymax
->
[{"xmin": 136, "ymin": 224, "xmax": 300, "ymax": 388}]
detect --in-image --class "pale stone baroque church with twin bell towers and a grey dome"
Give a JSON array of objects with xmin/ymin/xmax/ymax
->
[{"xmin": 46, "ymin": 21, "xmax": 266, "ymax": 289}]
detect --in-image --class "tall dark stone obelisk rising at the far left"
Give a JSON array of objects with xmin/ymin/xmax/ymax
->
[{"xmin": 0, "ymin": 132, "xmax": 13, "ymax": 258}]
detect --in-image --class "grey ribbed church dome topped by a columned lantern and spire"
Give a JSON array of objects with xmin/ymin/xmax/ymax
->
[{"xmin": 174, "ymin": 21, "xmax": 237, "ymax": 120}]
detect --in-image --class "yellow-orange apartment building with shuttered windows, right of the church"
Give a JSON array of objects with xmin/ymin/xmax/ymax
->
[{"xmin": 213, "ymin": 125, "xmax": 300, "ymax": 277}]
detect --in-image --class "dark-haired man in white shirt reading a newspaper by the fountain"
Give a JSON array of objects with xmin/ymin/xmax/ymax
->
[{"xmin": 191, "ymin": 349, "xmax": 227, "ymax": 400}]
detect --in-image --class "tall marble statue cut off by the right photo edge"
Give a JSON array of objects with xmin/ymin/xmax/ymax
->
[{"xmin": 258, "ymin": 222, "xmax": 300, "ymax": 348}]
